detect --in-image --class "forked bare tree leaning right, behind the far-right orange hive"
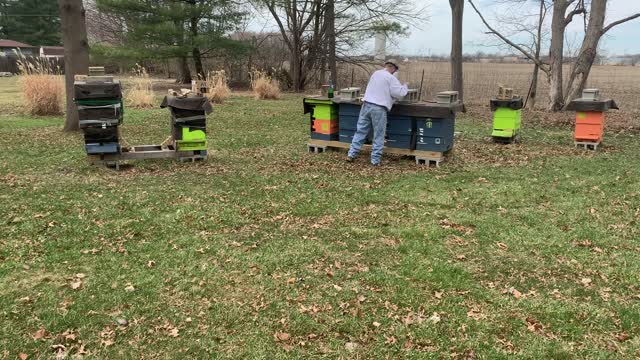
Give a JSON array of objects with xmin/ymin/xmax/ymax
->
[{"xmin": 564, "ymin": 0, "xmax": 640, "ymax": 107}]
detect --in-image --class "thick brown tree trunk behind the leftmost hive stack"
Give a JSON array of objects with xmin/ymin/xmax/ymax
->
[{"xmin": 58, "ymin": 0, "xmax": 89, "ymax": 131}]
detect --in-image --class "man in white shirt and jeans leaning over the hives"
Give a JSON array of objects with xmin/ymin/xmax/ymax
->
[{"xmin": 347, "ymin": 61, "xmax": 408, "ymax": 166}]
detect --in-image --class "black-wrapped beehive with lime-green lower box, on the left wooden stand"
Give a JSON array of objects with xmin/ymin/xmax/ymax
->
[{"xmin": 160, "ymin": 95, "xmax": 213, "ymax": 151}]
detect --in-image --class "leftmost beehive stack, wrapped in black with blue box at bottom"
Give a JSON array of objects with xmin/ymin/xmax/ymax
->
[{"xmin": 73, "ymin": 76, "xmax": 124, "ymax": 155}]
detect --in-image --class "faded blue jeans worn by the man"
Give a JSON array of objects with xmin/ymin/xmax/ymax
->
[{"xmin": 349, "ymin": 102, "xmax": 387, "ymax": 165}]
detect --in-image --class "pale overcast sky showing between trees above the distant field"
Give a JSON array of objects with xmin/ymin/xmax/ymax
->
[{"xmin": 394, "ymin": 0, "xmax": 640, "ymax": 55}]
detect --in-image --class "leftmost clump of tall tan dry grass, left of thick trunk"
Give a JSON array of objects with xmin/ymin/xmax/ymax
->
[{"xmin": 18, "ymin": 56, "xmax": 65, "ymax": 116}]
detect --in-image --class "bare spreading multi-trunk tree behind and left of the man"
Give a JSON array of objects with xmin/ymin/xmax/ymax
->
[{"xmin": 256, "ymin": 0, "xmax": 424, "ymax": 90}]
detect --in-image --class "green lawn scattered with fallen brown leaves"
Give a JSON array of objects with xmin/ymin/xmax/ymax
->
[{"xmin": 0, "ymin": 79, "xmax": 640, "ymax": 359}]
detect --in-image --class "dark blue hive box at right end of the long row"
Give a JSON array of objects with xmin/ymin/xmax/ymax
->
[{"xmin": 416, "ymin": 118, "xmax": 455, "ymax": 152}]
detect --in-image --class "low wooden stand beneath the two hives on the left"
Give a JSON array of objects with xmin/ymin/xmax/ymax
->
[{"xmin": 88, "ymin": 145, "xmax": 207, "ymax": 170}]
